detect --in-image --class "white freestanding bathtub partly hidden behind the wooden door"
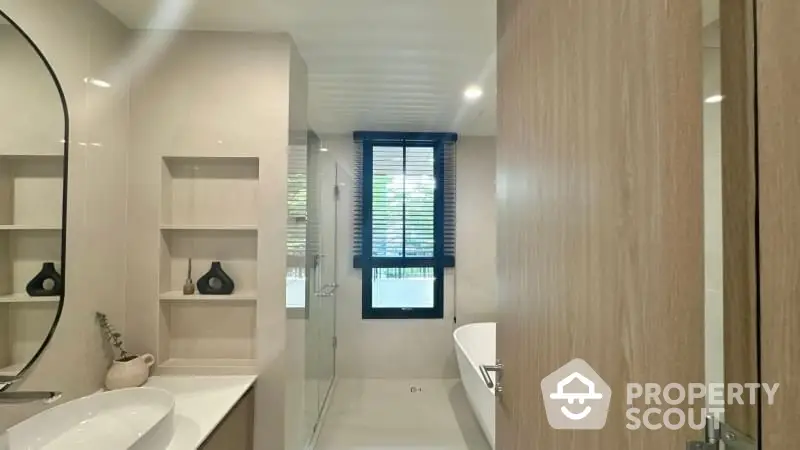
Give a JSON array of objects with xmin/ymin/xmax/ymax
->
[{"xmin": 453, "ymin": 323, "xmax": 497, "ymax": 449}]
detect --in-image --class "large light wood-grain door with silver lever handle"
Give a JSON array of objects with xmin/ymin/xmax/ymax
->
[{"xmin": 496, "ymin": 0, "xmax": 704, "ymax": 450}]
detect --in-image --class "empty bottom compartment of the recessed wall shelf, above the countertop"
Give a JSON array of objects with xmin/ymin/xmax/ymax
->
[{"xmin": 159, "ymin": 301, "xmax": 256, "ymax": 374}]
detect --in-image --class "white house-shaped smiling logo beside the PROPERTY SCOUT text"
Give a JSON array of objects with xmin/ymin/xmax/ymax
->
[{"xmin": 542, "ymin": 358, "xmax": 611, "ymax": 430}]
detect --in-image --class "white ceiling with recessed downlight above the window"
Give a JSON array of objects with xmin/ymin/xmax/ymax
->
[{"xmin": 92, "ymin": 0, "xmax": 496, "ymax": 135}]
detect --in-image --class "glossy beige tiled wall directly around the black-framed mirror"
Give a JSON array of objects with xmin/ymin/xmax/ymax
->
[{"xmin": 0, "ymin": 0, "xmax": 128, "ymax": 429}]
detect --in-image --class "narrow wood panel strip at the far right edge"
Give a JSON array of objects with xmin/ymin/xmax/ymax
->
[{"xmin": 756, "ymin": 0, "xmax": 800, "ymax": 450}]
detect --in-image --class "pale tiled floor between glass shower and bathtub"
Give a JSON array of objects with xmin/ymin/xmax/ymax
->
[{"xmin": 315, "ymin": 379, "xmax": 491, "ymax": 450}]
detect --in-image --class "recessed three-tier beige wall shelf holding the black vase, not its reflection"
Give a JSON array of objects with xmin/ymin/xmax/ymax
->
[{"xmin": 157, "ymin": 156, "xmax": 259, "ymax": 374}]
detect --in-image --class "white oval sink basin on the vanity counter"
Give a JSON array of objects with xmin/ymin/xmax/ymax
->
[{"xmin": 0, "ymin": 388, "xmax": 175, "ymax": 450}]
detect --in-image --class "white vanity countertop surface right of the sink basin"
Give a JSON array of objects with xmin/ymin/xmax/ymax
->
[{"xmin": 145, "ymin": 375, "xmax": 256, "ymax": 450}]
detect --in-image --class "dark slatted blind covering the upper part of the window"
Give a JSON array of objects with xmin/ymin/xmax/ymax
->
[{"xmin": 353, "ymin": 134, "xmax": 456, "ymax": 267}]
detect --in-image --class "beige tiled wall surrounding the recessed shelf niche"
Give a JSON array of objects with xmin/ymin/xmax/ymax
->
[{"xmin": 126, "ymin": 32, "xmax": 306, "ymax": 450}]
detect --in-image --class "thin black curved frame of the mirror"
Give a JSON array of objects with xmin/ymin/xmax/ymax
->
[{"xmin": 0, "ymin": 9, "xmax": 70, "ymax": 392}]
